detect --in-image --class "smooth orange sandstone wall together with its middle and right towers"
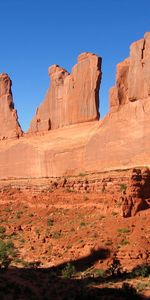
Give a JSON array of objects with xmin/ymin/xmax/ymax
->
[{"xmin": 0, "ymin": 33, "xmax": 150, "ymax": 178}]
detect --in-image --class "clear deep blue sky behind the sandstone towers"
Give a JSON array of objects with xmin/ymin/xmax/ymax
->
[{"xmin": 0, "ymin": 0, "xmax": 150, "ymax": 130}]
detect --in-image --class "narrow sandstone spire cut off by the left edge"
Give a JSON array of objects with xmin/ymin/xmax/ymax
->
[{"xmin": 0, "ymin": 74, "xmax": 22, "ymax": 140}]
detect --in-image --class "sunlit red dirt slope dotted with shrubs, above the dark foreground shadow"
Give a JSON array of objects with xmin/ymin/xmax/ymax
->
[{"xmin": 0, "ymin": 174, "xmax": 150, "ymax": 299}]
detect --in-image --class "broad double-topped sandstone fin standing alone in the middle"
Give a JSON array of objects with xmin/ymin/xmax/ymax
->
[{"xmin": 29, "ymin": 53, "xmax": 101, "ymax": 132}]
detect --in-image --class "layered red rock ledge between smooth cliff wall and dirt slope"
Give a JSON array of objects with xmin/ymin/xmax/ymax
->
[{"xmin": 0, "ymin": 168, "xmax": 150, "ymax": 218}]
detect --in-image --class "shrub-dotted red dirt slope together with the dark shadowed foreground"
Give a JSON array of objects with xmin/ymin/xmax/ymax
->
[{"xmin": 0, "ymin": 188, "xmax": 150, "ymax": 299}]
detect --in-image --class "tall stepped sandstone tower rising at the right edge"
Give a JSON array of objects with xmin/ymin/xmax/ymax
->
[{"xmin": 110, "ymin": 32, "xmax": 150, "ymax": 111}]
